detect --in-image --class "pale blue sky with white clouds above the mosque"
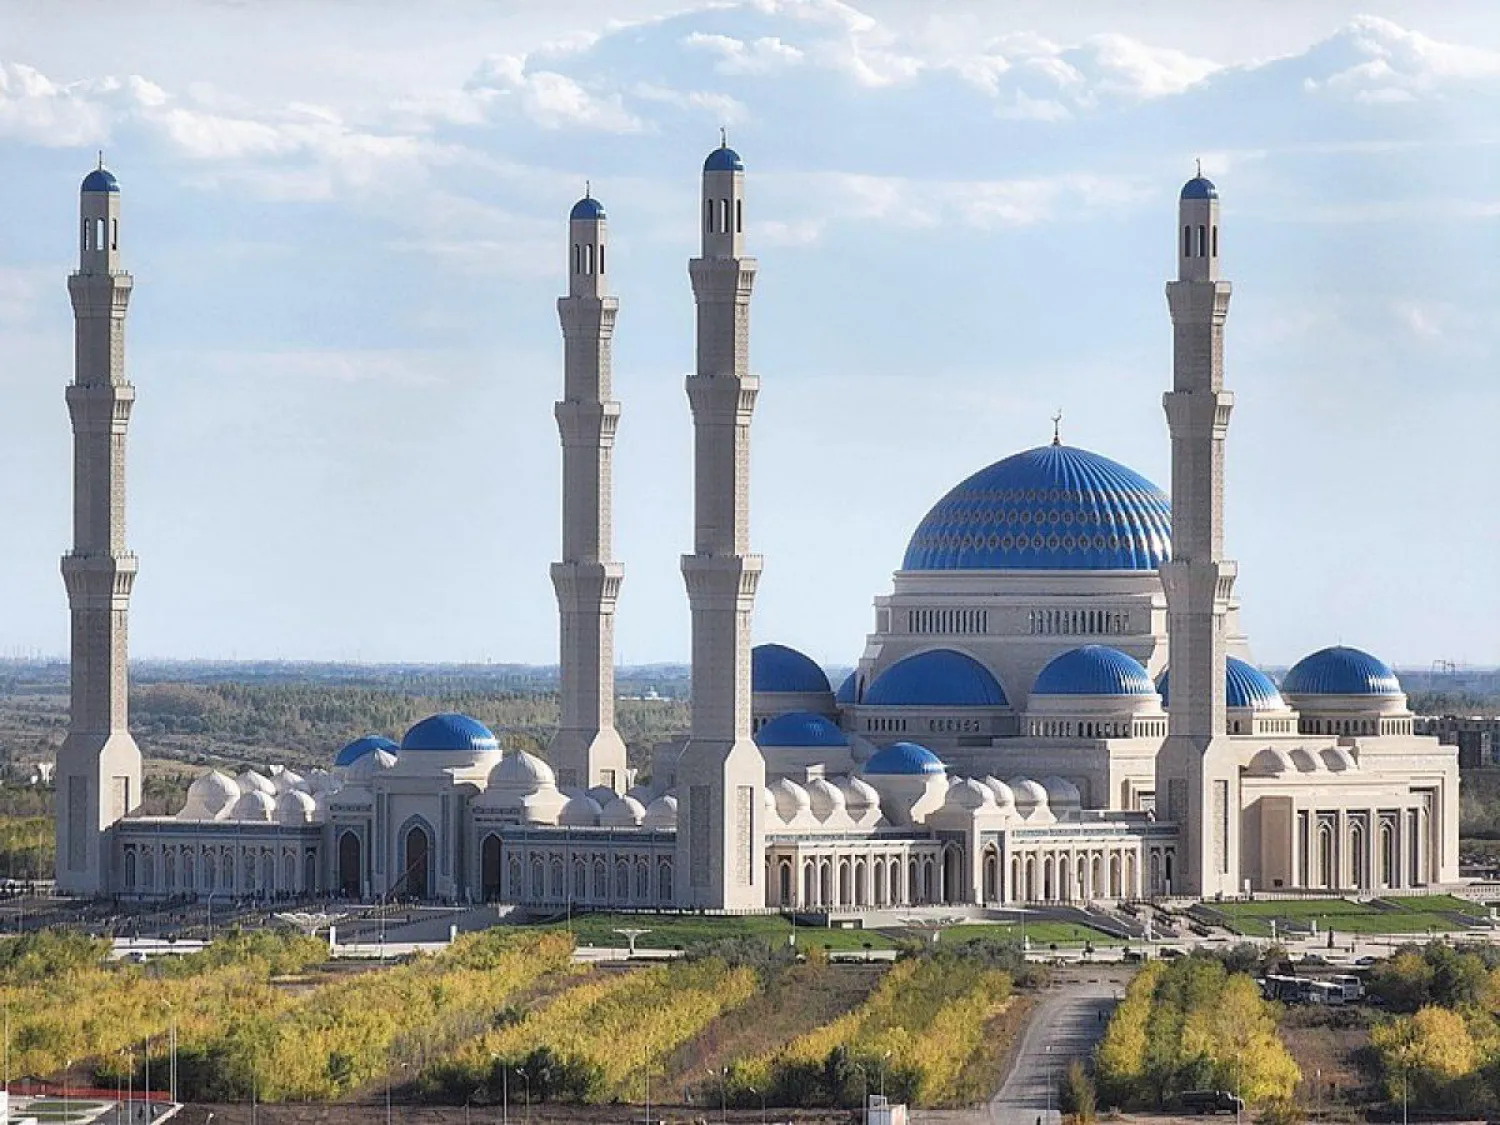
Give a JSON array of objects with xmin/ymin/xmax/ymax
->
[{"xmin": 0, "ymin": 0, "xmax": 1500, "ymax": 666}]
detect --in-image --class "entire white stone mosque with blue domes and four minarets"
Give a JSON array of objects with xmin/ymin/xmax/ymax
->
[{"xmin": 57, "ymin": 144, "xmax": 1458, "ymax": 914}]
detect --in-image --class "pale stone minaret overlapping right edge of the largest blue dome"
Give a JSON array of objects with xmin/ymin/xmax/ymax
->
[{"xmin": 1157, "ymin": 174, "xmax": 1239, "ymax": 896}]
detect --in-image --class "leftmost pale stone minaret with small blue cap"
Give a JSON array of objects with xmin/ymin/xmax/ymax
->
[{"xmin": 57, "ymin": 165, "xmax": 141, "ymax": 894}]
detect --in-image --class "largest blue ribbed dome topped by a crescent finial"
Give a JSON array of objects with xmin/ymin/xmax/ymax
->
[{"xmin": 902, "ymin": 446, "xmax": 1172, "ymax": 570}]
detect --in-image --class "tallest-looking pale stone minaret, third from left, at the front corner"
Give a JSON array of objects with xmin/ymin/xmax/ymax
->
[{"xmin": 674, "ymin": 144, "xmax": 765, "ymax": 909}]
